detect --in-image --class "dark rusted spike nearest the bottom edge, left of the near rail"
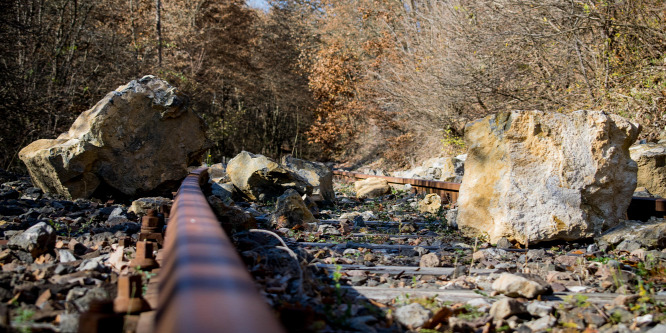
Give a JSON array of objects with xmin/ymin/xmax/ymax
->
[{"xmin": 79, "ymin": 301, "xmax": 123, "ymax": 333}]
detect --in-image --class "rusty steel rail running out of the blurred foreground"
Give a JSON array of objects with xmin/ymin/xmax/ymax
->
[{"xmin": 154, "ymin": 168, "xmax": 284, "ymax": 333}]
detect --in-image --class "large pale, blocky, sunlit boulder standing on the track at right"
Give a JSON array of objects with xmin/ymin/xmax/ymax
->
[{"xmin": 457, "ymin": 111, "xmax": 640, "ymax": 244}]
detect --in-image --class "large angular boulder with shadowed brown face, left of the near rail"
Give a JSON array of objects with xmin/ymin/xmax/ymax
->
[{"xmin": 19, "ymin": 76, "xmax": 206, "ymax": 198}]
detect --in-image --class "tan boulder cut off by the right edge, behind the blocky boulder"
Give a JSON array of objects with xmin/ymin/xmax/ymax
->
[{"xmin": 629, "ymin": 143, "xmax": 666, "ymax": 197}]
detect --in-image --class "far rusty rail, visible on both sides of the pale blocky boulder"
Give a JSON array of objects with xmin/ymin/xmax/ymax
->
[{"xmin": 333, "ymin": 170, "xmax": 666, "ymax": 221}]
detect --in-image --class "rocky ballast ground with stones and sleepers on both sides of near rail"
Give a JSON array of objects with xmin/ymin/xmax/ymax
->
[{"xmin": 0, "ymin": 173, "xmax": 666, "ymax": 332}]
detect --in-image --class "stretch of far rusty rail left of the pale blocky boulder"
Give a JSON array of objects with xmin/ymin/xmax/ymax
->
[{"xmin": 333, "ymin": 170, "xmax": 460, "ymax": 204}]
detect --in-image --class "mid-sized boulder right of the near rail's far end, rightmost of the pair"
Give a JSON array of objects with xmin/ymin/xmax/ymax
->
[{"xmin": 280, "ymin": 155, "xmax": 335, "ymax": 202}]
